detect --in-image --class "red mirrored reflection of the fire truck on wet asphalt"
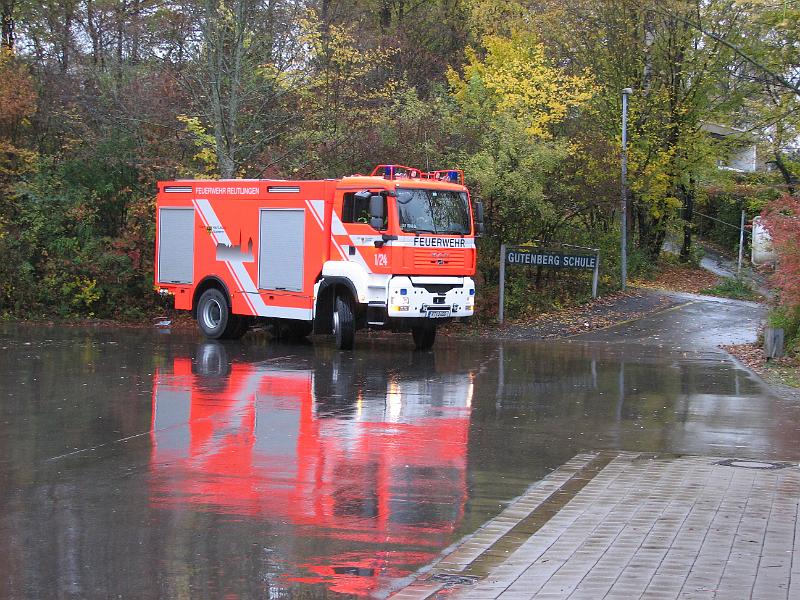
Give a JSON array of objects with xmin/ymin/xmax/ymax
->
[{"xmin": 151, "ymin": 343, "xmax": 473, "ymax": 594}]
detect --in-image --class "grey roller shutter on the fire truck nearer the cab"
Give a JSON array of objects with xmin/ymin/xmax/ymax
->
[{"xmin": 258, "ymin": 209, "xmax": 306, "ymax": 292}]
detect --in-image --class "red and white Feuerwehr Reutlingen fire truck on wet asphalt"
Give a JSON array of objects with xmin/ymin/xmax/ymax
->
[{"xmin": 155, "ymin": 165, "xmax": 483, "ymax": 349}]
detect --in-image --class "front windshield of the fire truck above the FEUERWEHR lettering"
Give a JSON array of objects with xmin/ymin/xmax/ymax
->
[{"xmin": 397, "ymin": 188, "xmax": 470, "ymax": 235}]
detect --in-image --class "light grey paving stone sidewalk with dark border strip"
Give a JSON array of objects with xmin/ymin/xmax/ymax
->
[{"xmin": 393, "ymin": 452, "xmax": 800, "ymax": 600}]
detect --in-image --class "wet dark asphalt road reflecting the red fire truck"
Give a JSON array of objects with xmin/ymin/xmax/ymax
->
[{"xmin": 0, "ymin": 298, "xmax": 800, "ymax": 598}]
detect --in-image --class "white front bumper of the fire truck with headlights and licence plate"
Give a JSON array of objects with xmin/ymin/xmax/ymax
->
[{"xmin": 386, "ymin": 277, "xmax": 475, "ymax": 319}]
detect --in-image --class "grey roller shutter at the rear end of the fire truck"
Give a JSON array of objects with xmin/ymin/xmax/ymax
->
[{"xmin": 158, "ymin": 208, "xmax": 194, "ymax": 283}]
